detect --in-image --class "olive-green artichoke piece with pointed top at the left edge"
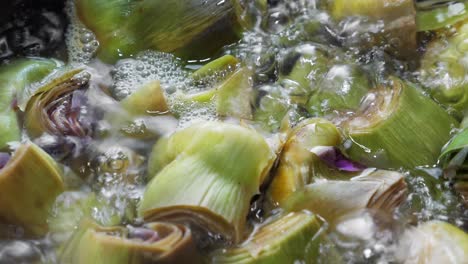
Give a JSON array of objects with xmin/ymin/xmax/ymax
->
[{"xmin": 0, "ymin": 142, "xmax": 64, "ymax": 235}]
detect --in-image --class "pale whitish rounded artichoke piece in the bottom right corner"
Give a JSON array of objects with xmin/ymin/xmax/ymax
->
[{"xmin": 396, "ymin": 221, "xmax": 468, "ymax": 264}]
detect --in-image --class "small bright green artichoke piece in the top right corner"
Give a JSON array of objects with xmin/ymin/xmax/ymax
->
[{"xmin": 416, "ymin": 0, "xmax": 468, "ymax": 31}]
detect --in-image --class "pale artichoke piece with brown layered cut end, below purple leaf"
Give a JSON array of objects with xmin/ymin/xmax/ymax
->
[{"xmin": 280, "ymin": 169, "xmax": 406, "ymax": 222}]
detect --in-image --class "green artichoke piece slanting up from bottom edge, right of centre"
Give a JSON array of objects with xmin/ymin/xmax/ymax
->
[{"xmin": 211, "ymin": 212, "xmax": 325, "ymax": 264}]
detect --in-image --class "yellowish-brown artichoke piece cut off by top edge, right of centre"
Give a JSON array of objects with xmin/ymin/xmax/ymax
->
[{"xmin": 326, "ymin": 0, "xmax": 417, "ymax": 59}]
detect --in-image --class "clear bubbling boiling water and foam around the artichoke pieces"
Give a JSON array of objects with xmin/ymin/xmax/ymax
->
[{"xmin": 0, "ymin": 0, "xmax": 468, "ymax": 263}]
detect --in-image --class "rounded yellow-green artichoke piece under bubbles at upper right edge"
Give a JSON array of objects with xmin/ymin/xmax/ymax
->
[{"xmin": 419, "ymin": 19, "xmax": 468, "ymax": 112}]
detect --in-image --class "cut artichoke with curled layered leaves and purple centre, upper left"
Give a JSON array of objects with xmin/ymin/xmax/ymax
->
[{"xmin": 24, "ymin": 69, "xmax": 91, "ymax": 138}]
